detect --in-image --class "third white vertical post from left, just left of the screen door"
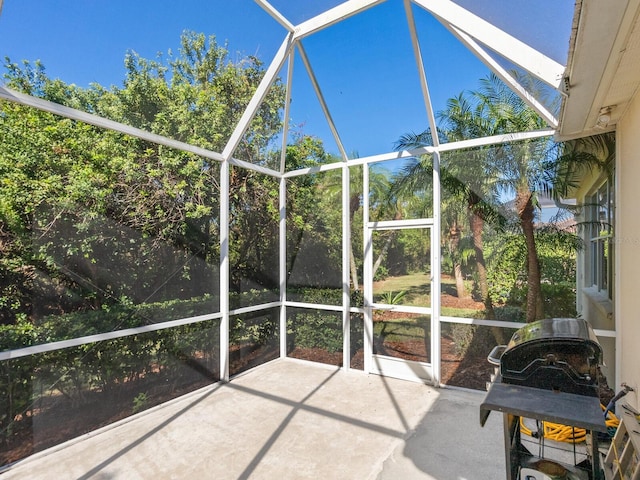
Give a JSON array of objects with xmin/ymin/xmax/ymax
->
[{"xmin": 342, "ymin": 162, "xmax": 351, "ymax": 370}]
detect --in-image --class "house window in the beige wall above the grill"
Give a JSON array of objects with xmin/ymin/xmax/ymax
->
[{"xmin": 587, "ymin": 177, "xmax": 615, "ymax": 299}]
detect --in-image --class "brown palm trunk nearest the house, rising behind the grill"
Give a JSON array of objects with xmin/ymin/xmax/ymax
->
[{"xmin": 516, "ymin": 191, "xmax": 544, "ymax": 322}]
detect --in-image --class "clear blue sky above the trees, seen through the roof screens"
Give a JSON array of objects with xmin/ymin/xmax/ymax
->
[{"xmin": 0, "ymin": 0, "xmax": 573, "ymax": 156}]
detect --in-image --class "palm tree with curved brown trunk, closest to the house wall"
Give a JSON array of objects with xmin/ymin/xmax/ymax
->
[{"xmin": 460, "ymin": 74, "xmax": 614, "ymax": 322}]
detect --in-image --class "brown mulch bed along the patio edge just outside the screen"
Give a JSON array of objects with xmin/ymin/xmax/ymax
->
[{"xmin": 0, "ymin": 337, "xmax": 491, "ymax": 465}]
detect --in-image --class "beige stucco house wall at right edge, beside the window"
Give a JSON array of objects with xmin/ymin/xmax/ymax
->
[{"xmin": 614, "ymin": 89, "xmax": 640, "ymax": 409}]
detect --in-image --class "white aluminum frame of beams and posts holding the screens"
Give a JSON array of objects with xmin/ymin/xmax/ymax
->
[{"xmin": 0, "ymin": 0, "xmax": 618, "ymax": 385}]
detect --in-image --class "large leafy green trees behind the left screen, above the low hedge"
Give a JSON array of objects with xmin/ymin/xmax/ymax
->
[{"xmin": 0, "ymin": 32, "xmax": 283, "ymax": 323}]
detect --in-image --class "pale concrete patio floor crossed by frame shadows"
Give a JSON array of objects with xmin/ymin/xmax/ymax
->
[{"xmin": 0, "ymin": 359, "xmax": 504, "ymax": 480}]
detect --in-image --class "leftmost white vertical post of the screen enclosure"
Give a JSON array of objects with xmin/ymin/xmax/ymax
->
[{"xmin": 220, "ymin": 160, "xmax": 229, "ymax": 382}]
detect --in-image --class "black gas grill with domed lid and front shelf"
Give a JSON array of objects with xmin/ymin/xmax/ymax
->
[{"xmin": 480, "ymin": 318, "xmax": 606, "ymax": 480}]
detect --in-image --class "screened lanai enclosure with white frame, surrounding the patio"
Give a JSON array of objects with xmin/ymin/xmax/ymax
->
[{"xmin": 0, "ymin": 0, "xmax": 612, "ymax": 464}]
